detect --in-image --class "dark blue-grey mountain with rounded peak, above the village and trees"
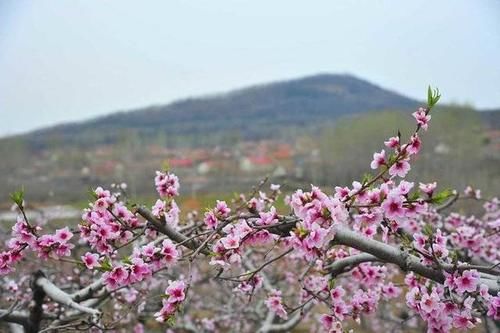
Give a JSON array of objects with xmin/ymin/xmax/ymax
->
[{"xmin": 20, "ymin": 74, "xmax": 417, "ymax": 148}]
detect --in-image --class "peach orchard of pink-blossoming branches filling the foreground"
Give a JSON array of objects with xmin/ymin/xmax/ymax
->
[{"xmin": 0, "ymin": 88, "xmax": 500, "ymax": 333}]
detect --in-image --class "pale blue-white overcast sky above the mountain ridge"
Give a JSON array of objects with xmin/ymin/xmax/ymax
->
[{"xmin": 0, "ymin": 0, "xmax": 500, "ymax": 136}]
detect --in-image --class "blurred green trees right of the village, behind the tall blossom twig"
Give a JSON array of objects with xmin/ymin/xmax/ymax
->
[{"xmin": 319, "ymin": 107, "xmax": 500, "ymax": 193}]
